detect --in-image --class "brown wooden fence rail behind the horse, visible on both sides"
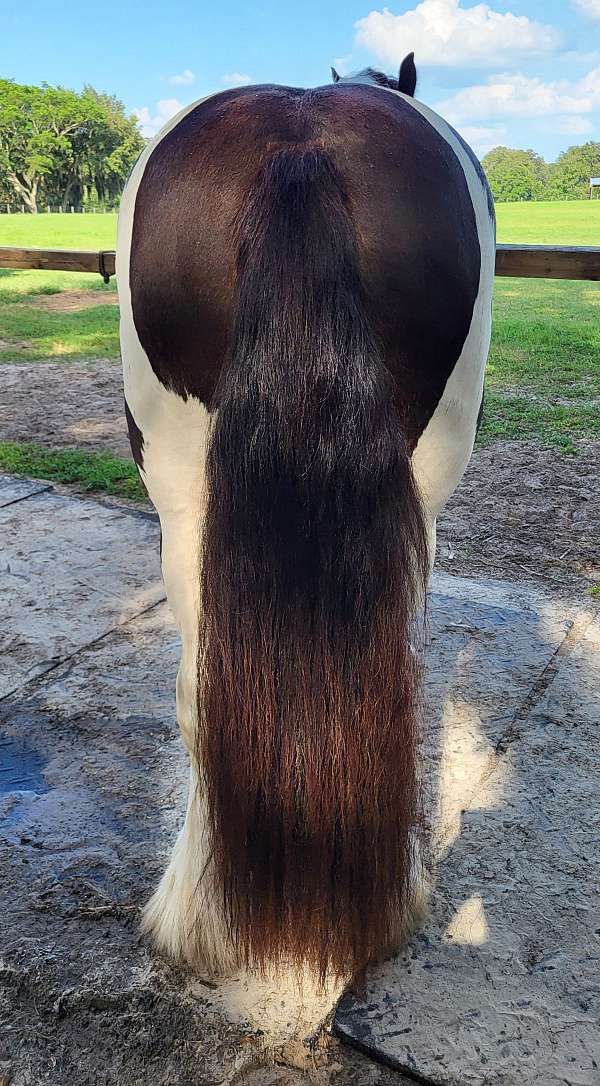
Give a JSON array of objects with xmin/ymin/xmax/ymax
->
[{"xmin": 0, "ymin": 245, "xmax": 600, "ymax": 282}]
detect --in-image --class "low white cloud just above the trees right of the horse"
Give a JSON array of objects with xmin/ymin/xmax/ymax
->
[{"xmin": 436, "ymin": 68, "xmax": 600, "ymax": 125}]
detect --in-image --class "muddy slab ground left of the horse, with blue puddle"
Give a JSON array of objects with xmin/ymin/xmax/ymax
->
[{"xmin": 0, "ymin": 478, "xmax": 421, "ymax": 1086}]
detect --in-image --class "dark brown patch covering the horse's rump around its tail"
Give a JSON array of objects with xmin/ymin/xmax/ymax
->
[{"xmin": 130, "ymin": 83, "xmax": 480, "ymax": 449}]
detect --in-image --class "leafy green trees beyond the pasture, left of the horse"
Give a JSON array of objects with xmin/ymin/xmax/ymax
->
[{"xmin": 0, "ymin": 79, "xmax": 143, "ymax": 213}]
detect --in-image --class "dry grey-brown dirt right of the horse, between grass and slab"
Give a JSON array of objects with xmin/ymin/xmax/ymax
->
[{"xmin": 437, "ymin": 441, "xmax": 600, "ymax": 594}]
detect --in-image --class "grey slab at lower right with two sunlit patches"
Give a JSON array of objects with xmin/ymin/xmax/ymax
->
[{"xmin": 335, "ymin": 615, "xmax": 600, "ymax": 1086}]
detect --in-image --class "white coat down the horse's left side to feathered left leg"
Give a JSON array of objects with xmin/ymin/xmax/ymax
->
[{"xmin": 116, "ymin": 91, "xmax": 233, "ymax": 972}]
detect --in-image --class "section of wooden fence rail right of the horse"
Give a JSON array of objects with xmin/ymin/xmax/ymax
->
[{"xmin": 496, "ymin": 245, "xmax": 600, "ymax": 280}]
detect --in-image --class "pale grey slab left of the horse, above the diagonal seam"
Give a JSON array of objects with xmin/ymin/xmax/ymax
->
[{"xmin": 0, "ymin": 480, "xmax": 164, "ymax": 697}]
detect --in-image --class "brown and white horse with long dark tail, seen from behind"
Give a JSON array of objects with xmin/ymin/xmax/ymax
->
[{"xmin": 117, "ymin": 55, "xmax": 495, "ymax": 994}]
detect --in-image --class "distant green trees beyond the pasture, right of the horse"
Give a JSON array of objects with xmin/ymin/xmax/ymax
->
[{"xmin": 482, "ymin": 141, "xmax": 600, "ymax": 200}]
